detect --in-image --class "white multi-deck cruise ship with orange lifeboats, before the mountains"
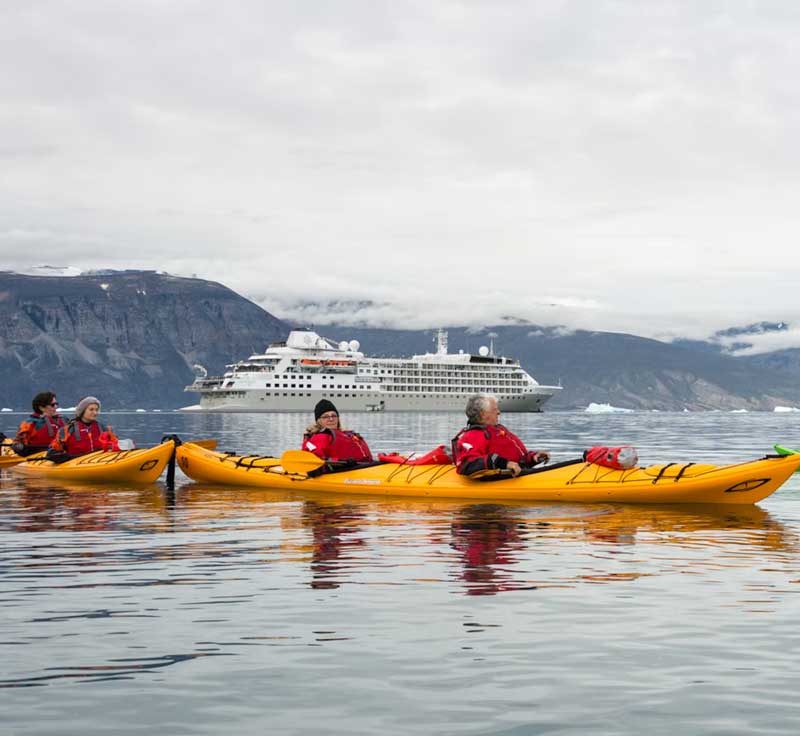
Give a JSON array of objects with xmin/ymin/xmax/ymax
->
[{"xmin": 185, "ymin": 330, "xmax": 561, "ymax": 412}]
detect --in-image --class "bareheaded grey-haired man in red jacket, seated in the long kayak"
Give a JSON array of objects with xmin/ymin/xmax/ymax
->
[{"xmin": 453, "ymin": 394, "xmax": 550, "ymax": 477}]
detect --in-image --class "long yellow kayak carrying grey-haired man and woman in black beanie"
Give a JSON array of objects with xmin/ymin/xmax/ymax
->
[{"xmin": 176, "ymin": 443, "xmax": 800, "ymax": 504}]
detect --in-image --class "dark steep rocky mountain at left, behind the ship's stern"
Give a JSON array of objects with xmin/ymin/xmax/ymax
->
[{"xmin": 0, "ymin": 271, "xmax": 289, "ymax": 409}]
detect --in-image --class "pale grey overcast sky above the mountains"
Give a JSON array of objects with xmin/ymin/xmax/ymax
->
[{"xmin": 0, "ymin": 0, "xmax": 800, "ymax": 346}]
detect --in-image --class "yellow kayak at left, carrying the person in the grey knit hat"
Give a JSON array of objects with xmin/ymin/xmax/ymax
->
[{"xmin": 11, "ymin": 440, "xmax": 175, "ymax": 483}]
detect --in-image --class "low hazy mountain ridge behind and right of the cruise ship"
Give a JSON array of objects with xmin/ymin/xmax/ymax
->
[{"xmin": 318, "ymin": 325, "xmax": 800, "ymax": 411}]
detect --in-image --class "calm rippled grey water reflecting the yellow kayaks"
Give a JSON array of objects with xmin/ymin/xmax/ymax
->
[{"xmin": 0, "ymin": 413, "xmax": 800, "ymax": 736}]
